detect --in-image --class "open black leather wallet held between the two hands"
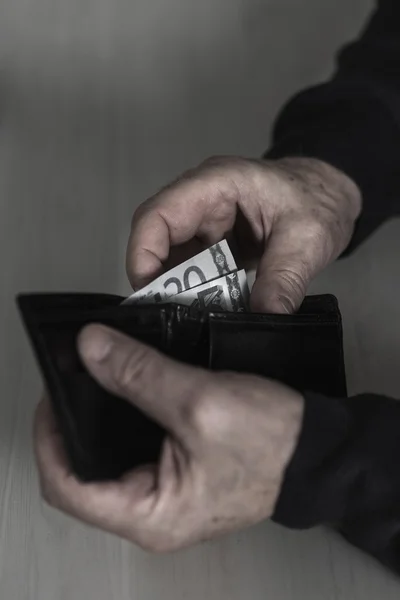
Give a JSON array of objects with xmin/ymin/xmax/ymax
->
[{"xmin": 18, "ymin": 293, "xmax": 346, "ymax": 481}]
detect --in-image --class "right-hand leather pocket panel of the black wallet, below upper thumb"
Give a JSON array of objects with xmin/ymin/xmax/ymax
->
[{"xmin": 209, "ymin": 314, "xmax": 347, "ymax": 397}]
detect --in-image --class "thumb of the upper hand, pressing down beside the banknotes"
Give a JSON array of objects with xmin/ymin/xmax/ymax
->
[{"xmin": 250, "ymin": 220, "xmax": 331, "ymax": 314}]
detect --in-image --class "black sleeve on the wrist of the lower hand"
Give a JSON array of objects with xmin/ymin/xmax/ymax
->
[{"xmin": 273, "ymin": 394, "xmax": 400, "ymax": 574}]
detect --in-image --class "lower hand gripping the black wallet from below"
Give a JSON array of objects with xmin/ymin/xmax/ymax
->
[{"xmin": 35, "ymin": 325, "xmax": 303, "ymax": 552}]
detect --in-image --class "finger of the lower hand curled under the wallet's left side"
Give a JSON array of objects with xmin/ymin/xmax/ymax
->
[{"xmin": 34, "ymin": 402, "xmax": 156, "ymax": 541}]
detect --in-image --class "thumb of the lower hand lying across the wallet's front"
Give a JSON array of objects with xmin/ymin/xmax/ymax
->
[{"xmin": 79, "ymin": 325, "xmax": 205, "ymax": 437}]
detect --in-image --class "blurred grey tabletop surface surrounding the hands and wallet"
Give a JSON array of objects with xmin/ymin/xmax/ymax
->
[{"xmin": 0, "ymin": 0, "xmax": 400, "ymax": 600}]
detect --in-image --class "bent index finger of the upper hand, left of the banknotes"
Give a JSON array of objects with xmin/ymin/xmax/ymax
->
[{"xmin": 126, "ymin": 165, "xmax": 236, "ymax": 289}]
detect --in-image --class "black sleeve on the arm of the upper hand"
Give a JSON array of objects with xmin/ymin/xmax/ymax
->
[{"xmin": 265, "ymin": 0, "xmax": 400, "ymax": 253}]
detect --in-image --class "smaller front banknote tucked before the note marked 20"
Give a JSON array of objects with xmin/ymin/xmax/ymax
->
[{"xmin": 168, "ymin": 269, "xmax": 250, "ymax": 312}]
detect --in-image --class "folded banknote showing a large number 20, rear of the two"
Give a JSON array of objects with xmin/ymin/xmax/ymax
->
[{"xmin": 123, "ymin": 240, "xmax": 237, "ymax": 304}]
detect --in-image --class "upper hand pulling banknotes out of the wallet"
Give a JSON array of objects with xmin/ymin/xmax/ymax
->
[{"xmin": 127, "ymin": 157, "xmax": 361, "ymax": 313}]
